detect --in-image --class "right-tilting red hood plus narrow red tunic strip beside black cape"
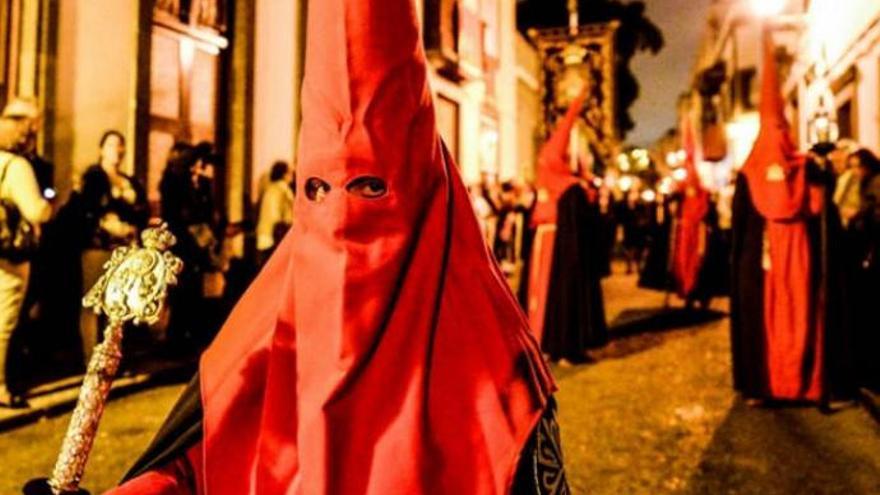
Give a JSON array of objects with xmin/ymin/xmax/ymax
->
[{"xmin": 528, "ymin": 95, "xmax": 586, "ymax": 342}]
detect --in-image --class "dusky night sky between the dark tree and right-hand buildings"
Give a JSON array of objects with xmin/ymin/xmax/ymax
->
[{"xmin": 627, "ymin": 0, "xmax": 710, "ymax": 145}]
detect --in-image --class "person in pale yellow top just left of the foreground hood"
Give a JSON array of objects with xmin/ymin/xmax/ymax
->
[{"xmin": 257, "ymin": 161, "xmax": 294, "ymax": 266}]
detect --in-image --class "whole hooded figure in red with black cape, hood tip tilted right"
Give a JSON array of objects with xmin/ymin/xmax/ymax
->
[{"xmin": 529, "ymin": 88, "xmax": 608, "ymax": 363}]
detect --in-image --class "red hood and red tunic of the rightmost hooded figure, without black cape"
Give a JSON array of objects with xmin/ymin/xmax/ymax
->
[{"xmin": 742, "ymin": 33, "xmax": 825, "ymax": 401}]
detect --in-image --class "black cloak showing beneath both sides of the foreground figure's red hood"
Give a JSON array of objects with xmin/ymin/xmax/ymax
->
[{"xmin": 122, "ymin": 373, "xmax": 569, "ymax": 495}]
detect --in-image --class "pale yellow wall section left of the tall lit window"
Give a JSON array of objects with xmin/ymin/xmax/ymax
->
[{"xmin": 46, "ymin": 0, "xmax": 139, "ymax": 196}]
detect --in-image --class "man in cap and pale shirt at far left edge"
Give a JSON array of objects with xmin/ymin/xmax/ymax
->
[{"xmin": 0, "ymin": 117, "xmax": 51, "ymax": 407}]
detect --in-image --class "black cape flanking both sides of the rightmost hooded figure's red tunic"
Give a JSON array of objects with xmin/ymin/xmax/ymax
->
[{"xmin": 730, "ymin": 174, "xmax": 855, "ymax": 399}]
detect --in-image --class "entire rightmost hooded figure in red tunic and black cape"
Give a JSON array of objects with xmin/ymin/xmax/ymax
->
[{"xmin": 731, "ymin": 33, "xmax": 826, "ymax": 401}]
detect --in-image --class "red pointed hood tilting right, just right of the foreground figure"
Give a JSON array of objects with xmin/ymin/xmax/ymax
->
[{"xmin": 532, "ymin": 92, "xmax": 587, "ymax": 225}]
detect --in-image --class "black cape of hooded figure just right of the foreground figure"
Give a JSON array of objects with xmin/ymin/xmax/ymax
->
[{"xmin": 543, "ymin": 184, "xmax": 608, "ymax": 362}]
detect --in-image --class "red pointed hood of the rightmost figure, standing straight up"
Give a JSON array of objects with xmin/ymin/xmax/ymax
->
[{"xmin": 742, "ymin": 31, "xmax": 807, "ymax": 219}]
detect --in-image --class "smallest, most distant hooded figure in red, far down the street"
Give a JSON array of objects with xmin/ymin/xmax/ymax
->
[{"xmin": 672, "ymin": 118, "xmax": 710, "ymax": 299}]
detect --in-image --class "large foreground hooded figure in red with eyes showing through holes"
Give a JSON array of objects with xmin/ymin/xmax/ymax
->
[{"xmin": 115, "ymin": 0, "xmax": 565, "ymax": 495}]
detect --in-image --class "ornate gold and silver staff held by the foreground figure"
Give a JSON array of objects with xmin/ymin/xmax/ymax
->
[{"xmin": 25, "ymin": 225, "xmax": 183, "ymax": 495}]
